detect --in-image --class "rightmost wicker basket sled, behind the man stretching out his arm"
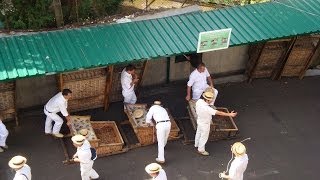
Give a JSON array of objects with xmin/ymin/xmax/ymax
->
[{"xmin": 187, "ymin": 100, "xmax": 239, "ymax": 141}]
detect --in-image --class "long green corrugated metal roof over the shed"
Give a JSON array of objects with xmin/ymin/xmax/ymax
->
[{"xmin": 0, "ymin": 0, "xmax": 320, "ymax": 80}]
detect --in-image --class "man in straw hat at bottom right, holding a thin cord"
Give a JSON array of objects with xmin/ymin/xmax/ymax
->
[{"xmin": 219, "ymin": 142, "xmax": 248, "ymax": 180}]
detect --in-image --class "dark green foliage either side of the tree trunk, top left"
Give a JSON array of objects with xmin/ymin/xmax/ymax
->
[{"xmin": 0, "ymin": 0, "xmax": 123, "ymax": 29}]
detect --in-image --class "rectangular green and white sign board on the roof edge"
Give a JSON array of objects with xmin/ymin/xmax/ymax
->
[{"xmin": 197, "ymin": 28, "xmax": 232, "ymax": 53}]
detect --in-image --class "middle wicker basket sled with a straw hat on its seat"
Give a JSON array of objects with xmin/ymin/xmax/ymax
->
[{"xmin": 124, "ymin": 104, "xmax": 180, "ymax": 146}]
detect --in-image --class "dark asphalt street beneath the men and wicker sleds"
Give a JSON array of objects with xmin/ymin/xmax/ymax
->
[{"xmin": 0, "ymin": 77, "xmax": 320, "ymax": 180}]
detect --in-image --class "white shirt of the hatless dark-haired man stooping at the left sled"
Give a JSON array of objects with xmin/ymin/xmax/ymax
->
[{"xmin": 45, "ymin": 92, "xmax": 69, "ymax": 116}]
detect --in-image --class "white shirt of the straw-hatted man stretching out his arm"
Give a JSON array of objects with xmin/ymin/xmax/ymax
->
[{"xmin": 196, "ymin": 99, "xmax": 217, "ymax": 124}]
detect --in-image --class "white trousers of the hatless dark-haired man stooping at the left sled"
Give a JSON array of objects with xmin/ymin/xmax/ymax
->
[{"xmin": 44, "ymin": 109, "xmax": 63, "ymax": 134}]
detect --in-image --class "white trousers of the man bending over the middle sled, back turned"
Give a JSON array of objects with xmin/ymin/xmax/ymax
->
[{"xmin": 156, "ymin": 121, "xmax": 171, "ymax": 161}]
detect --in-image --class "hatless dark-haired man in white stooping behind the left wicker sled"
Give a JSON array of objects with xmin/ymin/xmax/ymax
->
[{"xmin": 44, "ymin": 89, "xmax": 72, "ymax": 138}]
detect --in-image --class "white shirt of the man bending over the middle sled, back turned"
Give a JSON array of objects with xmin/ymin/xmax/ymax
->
[{"xmin": 146, "ymin": 105, "xmax": 170, "ymax": 123}]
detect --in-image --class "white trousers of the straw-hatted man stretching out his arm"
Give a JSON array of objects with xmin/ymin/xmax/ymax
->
[{"xmin": 194, "ymin": 124, "xmax": 210, "ymax": 152}]
